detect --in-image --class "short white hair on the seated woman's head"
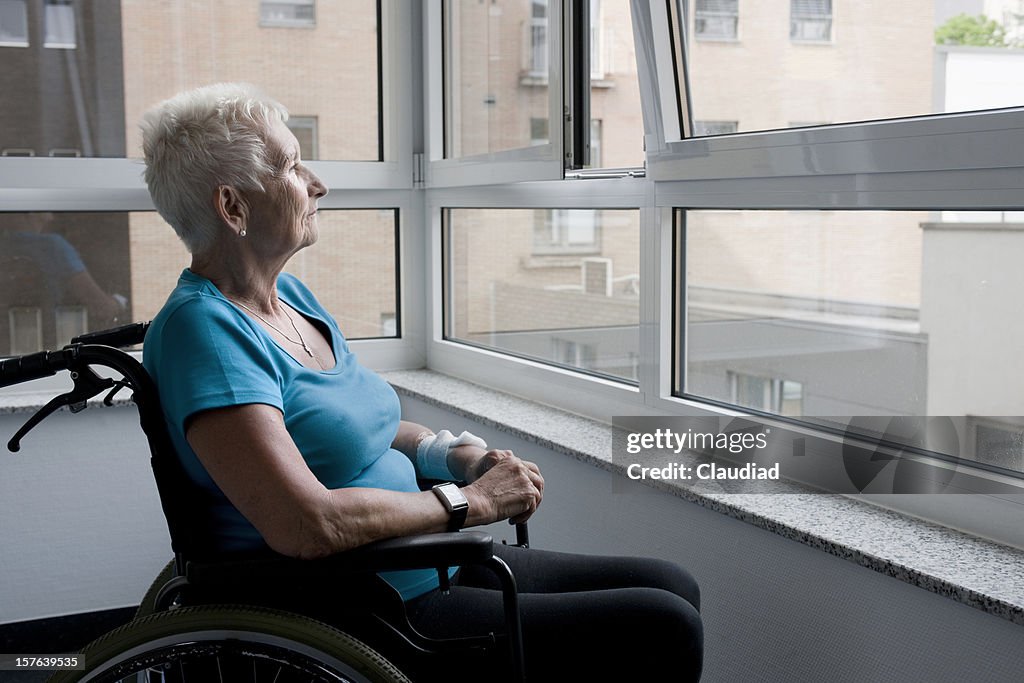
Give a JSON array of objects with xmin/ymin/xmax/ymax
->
[{"xmin": 141, "ymin": 83, "xmax": 288, "ymax": 254}]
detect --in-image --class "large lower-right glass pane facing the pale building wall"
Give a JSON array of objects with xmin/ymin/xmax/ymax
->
[{"xmin": 678, "ymin": 211, "xmax": 1024, "ymax": 475}]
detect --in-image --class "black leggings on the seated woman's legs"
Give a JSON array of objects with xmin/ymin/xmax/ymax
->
[{"xmin": 408, "ymin": 545, "xmax": 703, "ymax": 682}]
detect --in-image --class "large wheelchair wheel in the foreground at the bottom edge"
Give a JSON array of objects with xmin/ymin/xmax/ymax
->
[{"xmin": 50, "ymin": 605, "xmax": 409, "ymax": 683}]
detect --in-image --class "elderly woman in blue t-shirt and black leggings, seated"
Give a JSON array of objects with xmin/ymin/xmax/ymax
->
[{"xmin": 142, "ymin": 85, "xmax": 702, "ymax": 680}]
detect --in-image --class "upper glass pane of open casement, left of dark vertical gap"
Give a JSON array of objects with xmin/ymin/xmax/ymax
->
[{"xmin": 444, "ymin": 0, "xmax": 560, "ymax": 159}]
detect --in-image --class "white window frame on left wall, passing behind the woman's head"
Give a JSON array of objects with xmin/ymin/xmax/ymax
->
[{"xmin": 0, "ymin": 0, "xmax": 425, "ymax": 395}]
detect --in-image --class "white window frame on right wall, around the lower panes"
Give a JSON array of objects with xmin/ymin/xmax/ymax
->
[{"xmin": 426, "ymin": 0, "xmax": 1024, "ymax": 547}]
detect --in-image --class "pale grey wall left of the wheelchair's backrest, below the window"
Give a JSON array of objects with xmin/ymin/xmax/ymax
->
[{"xmin": 0, "ymin": 408, "xmax": 171, "ymax": 624}]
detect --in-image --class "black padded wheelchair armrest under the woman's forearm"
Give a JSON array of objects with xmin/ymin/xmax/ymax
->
[{"xmin": 185, "ymin": 531, "xmax": 494, "ymax": 586}]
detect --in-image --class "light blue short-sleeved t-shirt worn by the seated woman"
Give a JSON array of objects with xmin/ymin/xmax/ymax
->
[{"xmin": 142, "ymin": 269, "xmax": 438, "ymax": 600}]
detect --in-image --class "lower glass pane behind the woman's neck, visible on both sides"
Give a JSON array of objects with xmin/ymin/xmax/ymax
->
[{"xmin": 0, "ymin": 209, "xmax": 399, "ymax": 355}]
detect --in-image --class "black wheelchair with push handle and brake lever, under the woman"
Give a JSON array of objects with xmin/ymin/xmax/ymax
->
[{"xmin": 6, "ymin": 323, "xmax": 528, "ymax": 683}]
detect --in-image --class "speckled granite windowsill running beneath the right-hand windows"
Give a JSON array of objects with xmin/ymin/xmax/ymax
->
[{"xmin": 384, "ymin": 370, "xmax": 1024, "ymax": 625}]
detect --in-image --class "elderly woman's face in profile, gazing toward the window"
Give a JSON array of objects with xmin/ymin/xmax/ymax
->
[{"xmin": 247, "ymin": 121, "xmax": 327, "ymax": 256}]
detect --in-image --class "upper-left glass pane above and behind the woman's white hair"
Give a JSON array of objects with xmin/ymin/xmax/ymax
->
[{"xmin": 0, "ymin": 0, "xmax": 381, "ymax": 161}]
